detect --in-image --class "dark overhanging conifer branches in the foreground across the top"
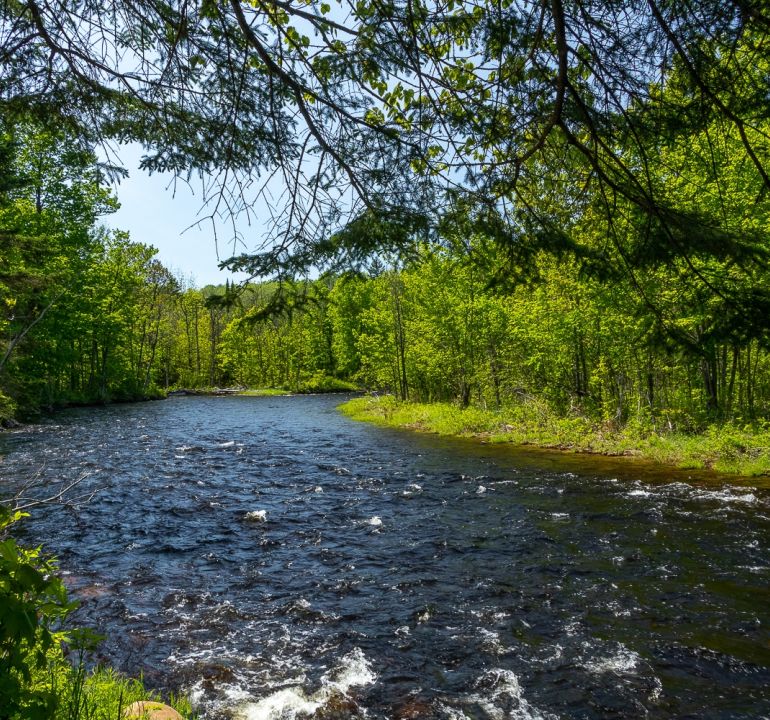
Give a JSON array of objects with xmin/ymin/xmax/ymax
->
[{"xmin": 0, "ymin": 0, "xmax": 770, "ymax": 277}]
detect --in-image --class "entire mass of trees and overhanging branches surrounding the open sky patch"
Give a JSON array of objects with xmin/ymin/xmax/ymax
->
[{"xmin": 0, "ymin": 2, "xmax": 770, "ymax": 432}]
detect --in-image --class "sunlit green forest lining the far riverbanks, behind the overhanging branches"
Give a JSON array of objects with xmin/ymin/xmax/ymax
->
[{"xmin": 0, "ymin": 108, "xmax": 770, "ymax": 430}]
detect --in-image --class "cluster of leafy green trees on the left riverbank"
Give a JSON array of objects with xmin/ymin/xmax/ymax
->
[{"xmin": 0, "ymin": 123, "xmax": 190, "ymax": 417}]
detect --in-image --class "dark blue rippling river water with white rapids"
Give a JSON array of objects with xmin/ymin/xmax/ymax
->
[{"xmin": 0, "ymin": 396, "xmax": 770, "ymax": 720}]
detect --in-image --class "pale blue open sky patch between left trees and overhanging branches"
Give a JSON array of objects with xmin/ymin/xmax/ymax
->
[{"xmin": 102, "ymin": 146, "xmax": 256, "ymax": 288}]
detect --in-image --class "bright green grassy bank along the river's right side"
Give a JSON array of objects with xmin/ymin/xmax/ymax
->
[{"xmin": 339, "ymin": 396, "xmax": 770, "ymax": 477}]
